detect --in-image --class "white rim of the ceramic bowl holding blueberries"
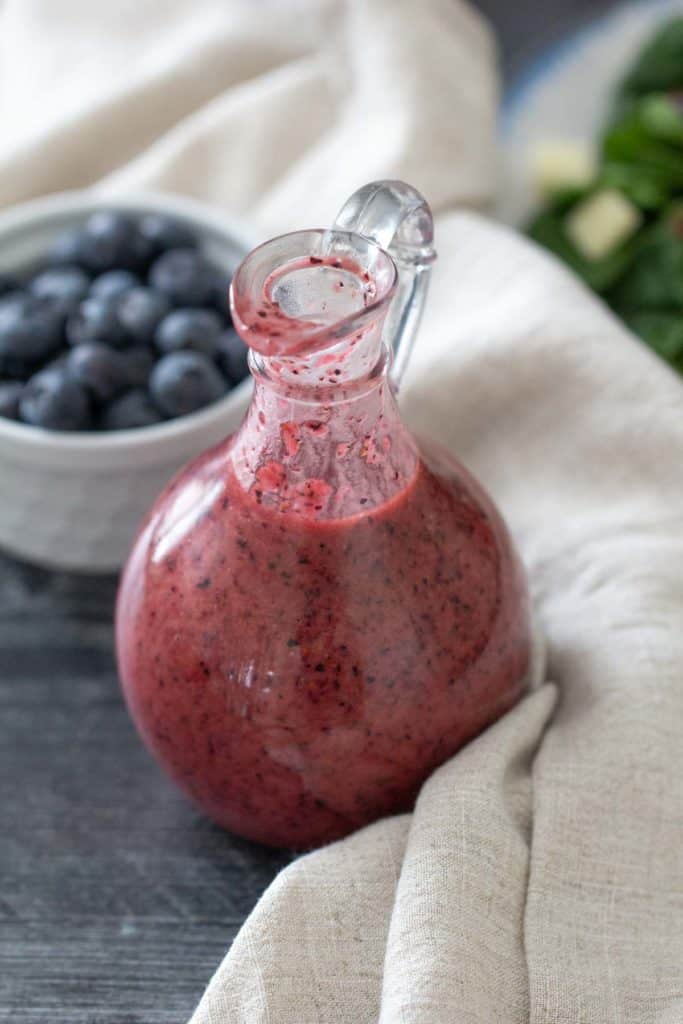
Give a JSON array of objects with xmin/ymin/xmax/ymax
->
[{"xmin": 0, "ymin": 188, "xmax": 254, "ymax": 454}]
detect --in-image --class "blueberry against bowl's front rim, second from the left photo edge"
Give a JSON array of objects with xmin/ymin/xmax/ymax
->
[{"xmin": 19, "ymin": 367, "xmax": 90, "ymax": 430}]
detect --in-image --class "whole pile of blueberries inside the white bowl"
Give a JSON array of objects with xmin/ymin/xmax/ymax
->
[{"xmin": 0, "ymin": 210, "xmax": 248, "ymax": 430}]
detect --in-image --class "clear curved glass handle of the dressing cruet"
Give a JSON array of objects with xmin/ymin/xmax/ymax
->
[{"xmin": 334, "ymin": 181, "xmax": 436, "ymax": 388}]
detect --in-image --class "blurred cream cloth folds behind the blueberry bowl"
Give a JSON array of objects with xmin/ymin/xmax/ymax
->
[{"xmin": 0, "ymin": 0, "xmax": 498, "ymax": 233}]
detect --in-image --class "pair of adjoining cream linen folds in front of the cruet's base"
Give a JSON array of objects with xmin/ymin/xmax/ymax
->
[{"xmin": 191, "ymin": 685, "xmax": 555, "ymax": 1024}]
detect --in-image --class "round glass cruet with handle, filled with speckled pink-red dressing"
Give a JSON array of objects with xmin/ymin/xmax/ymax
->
[{"xmin": 117, "ymin": 181, "xmax": 530, "ymax": 848}]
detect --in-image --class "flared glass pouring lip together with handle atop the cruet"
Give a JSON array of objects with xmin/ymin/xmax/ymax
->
[{"xmin": 230, "ymin": 181, "xmax": 436, "ymax": 387}]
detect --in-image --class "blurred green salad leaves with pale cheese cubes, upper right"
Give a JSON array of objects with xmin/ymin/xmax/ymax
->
[{"xmin": 528, "ymin": 17, "xmax": 683, "ymax": 374}]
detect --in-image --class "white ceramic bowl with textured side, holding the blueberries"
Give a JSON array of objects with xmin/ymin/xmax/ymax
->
[{"xmin": 0, "ymin": 193, "xmax": 252, "ymax": 572}]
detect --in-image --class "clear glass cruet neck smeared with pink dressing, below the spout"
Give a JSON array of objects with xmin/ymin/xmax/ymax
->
[{"xmin": 230, "ymin": 356, "xmax": 418, "ymax": 520}]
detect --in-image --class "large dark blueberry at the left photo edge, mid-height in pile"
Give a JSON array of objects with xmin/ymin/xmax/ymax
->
[{"xmin": 0, "ymin": 292, "xmax": 63, "ymax": 362}]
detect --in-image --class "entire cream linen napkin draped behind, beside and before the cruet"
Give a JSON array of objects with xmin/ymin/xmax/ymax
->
[{"xmin": 0, "ymin": 0, "xmax": 683, "ymax": 1024}]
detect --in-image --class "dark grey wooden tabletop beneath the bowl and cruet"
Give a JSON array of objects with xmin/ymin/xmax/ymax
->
[{"xmin": 0, "ymin": 0, "xmax": 610, "ymax": 1024}]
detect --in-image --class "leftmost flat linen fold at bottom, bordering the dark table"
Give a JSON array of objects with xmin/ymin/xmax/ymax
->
[{"xmin": 190, "ymin": 815, "xmax": 410, "ymax": 1024}]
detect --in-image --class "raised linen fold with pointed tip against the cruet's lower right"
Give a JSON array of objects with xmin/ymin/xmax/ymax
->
[{"xmin": 380, "ymin": 684, "xmax": 555, "ymax": 1024}]
